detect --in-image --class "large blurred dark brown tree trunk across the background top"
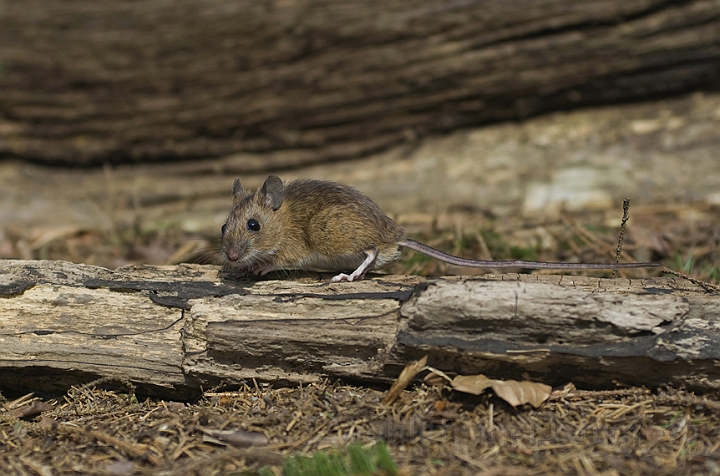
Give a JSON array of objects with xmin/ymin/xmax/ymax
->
[{"xmin": 0, "ymin": 0, "xmax": 720, "ymax": 166}]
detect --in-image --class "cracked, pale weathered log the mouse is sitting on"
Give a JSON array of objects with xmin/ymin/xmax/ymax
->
[{"xmin": 0, "ymin": 260, "xmax": 720, "ymax": 398}]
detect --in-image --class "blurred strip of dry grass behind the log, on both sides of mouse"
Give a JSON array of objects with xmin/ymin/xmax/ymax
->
[{"xmin": 0, "ymin": 204, "xmax": 720, "ymax": 284}]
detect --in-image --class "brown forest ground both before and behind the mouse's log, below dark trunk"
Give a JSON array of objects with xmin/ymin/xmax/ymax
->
[{"xmin": 0, "ymin": 95, "xmax": 720, "ymax": 476}]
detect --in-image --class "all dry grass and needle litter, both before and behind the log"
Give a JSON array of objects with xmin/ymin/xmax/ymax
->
[{"xmin": 0, "ymin": 202, "xmax": 720, "ymax": 476}]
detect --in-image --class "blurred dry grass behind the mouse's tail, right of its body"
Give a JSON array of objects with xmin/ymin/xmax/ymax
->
[{"xmin": 391, "ymin": 205, "xmax": 720, "ymax": 284}]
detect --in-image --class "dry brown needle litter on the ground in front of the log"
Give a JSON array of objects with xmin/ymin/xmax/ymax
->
[{"xmin": 0, "ymin": 383, "xmax": 720, "ymax": 475}]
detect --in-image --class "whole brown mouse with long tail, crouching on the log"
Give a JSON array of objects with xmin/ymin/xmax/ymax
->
[{"xmin": 221, "ymin": 175, "xmax": 660, "ymax": 282}]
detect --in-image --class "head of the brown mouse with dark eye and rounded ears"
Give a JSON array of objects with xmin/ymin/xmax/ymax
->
[{"xmin": 222, "ymin": 175, "xmax": 286, "ymax": 272}]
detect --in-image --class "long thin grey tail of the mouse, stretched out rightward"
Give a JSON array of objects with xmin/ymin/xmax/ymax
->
[{"xmin": 398, "ymin": 239, "xmax": 661, "ymax": 269}]
